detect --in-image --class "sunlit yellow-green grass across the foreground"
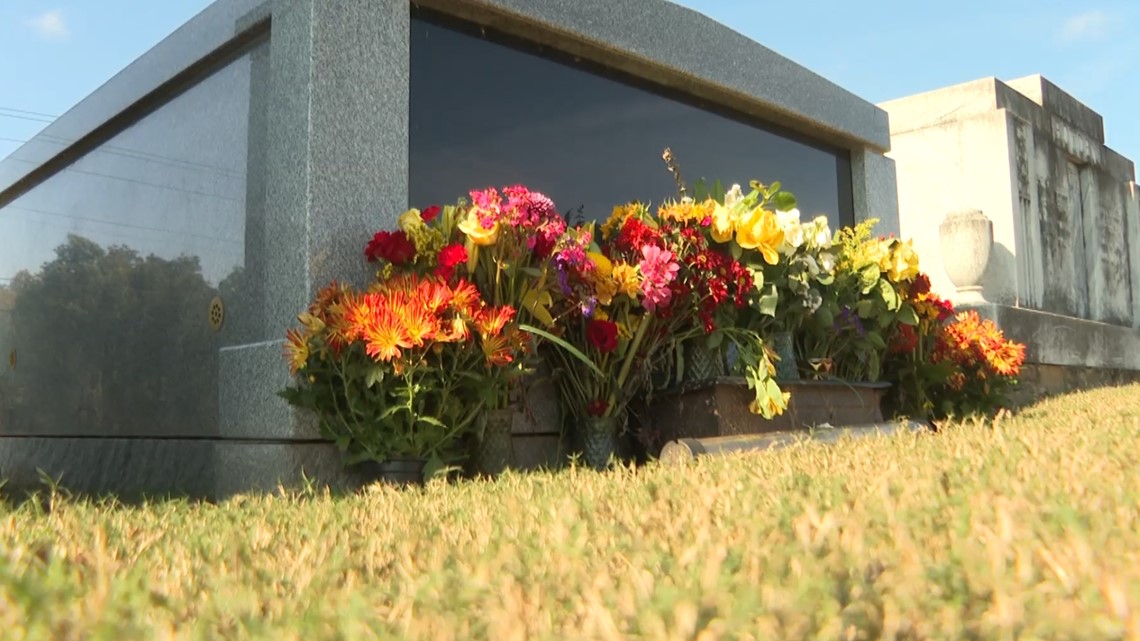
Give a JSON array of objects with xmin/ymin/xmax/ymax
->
[{"xmin": 0, "ymin": 386, "xmax": 1140, "ymax": 641}]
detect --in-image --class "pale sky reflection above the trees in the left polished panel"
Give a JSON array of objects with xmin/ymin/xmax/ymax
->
[{"xmin": 0, "ymin": 49, "xmax": 251, "ymax": 285}]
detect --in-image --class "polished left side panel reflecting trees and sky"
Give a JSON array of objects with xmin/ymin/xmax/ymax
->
[{"xmin": 0, "ymin": 42, "xmax": 269, "ymax": 437}]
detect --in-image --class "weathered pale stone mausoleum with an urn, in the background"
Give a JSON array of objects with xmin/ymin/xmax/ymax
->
[{"xmin": 880, "ymin": 75, "xmax": 1140, "ymax": 400}]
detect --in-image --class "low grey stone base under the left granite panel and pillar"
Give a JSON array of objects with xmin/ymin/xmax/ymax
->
[{"xmin": 0, "ymin": 437, "xmax": 361, "ymax": 501}]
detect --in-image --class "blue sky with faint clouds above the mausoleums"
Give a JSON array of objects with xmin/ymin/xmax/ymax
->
[{"xmin": 0, "ymin": 0, "xmax": 1140, "ymax": 160}]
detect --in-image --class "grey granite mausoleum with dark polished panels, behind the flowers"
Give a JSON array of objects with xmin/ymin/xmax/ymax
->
[{"xmin": 0, "ymin": 0, "xmax": 893, "ymax": 497}]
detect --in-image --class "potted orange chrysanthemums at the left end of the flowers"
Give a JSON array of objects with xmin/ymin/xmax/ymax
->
[{"xmin": 282, "ymin": 271, "xmax": 526, "ymax": 469}]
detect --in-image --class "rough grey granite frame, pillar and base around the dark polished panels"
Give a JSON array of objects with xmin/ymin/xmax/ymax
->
[{"xmin": 0, "ymin": 0, "xmax": 897, "ymax": 497}]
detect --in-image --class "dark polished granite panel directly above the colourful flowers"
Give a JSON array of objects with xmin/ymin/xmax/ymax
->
[{"xmin": 410, "ymin": 19, "xmax": 839, "ymax": 225}]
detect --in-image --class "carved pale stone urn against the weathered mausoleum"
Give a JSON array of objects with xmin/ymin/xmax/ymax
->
[{"xmin": 938, "ymin": 210, "xmax": 994, "ymax": 305}]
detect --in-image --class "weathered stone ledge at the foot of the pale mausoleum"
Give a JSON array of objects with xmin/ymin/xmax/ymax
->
[{"xmin": 959, "ymin": 303, "xmax": 1140, "ymax": 371}]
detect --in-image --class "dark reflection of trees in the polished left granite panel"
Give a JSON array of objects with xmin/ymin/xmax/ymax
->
[{"xmin": 0, "ymin": 235, "xmax": 238, "ymax": 436}]
